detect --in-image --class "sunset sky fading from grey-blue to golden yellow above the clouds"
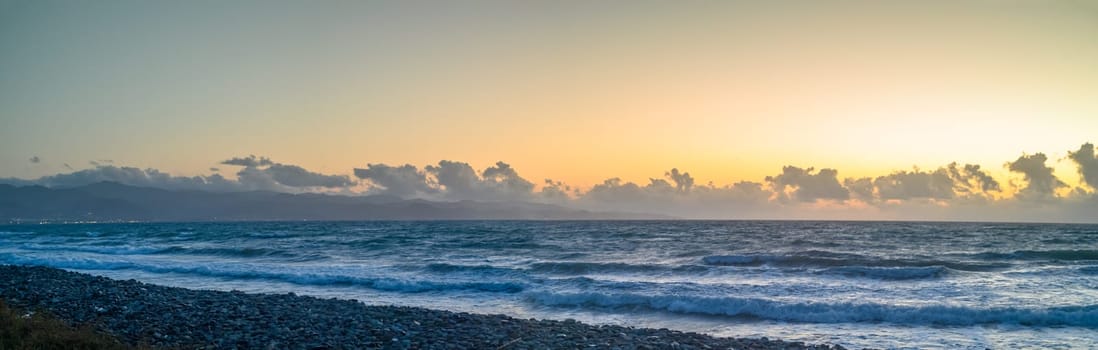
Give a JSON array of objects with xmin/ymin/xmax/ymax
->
[{"xmin": 0, "ymin": 0, "xmax": 1098, "ymax": 218}]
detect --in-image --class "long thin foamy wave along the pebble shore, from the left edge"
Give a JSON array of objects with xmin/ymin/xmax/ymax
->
[{"xmin": 0, "ymin": 253, "xmax": 525, "ymax": 293}]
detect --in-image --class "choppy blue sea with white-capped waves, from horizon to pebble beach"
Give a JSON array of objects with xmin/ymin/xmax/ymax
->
[{"xmin": 0, "ymin": 221, "xmax": 1098, "ymax": 349}]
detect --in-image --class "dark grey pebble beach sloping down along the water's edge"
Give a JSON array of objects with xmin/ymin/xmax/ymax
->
[{"xmin": 0, "ymin": 266, "xmax": 842, "ymax": 350}]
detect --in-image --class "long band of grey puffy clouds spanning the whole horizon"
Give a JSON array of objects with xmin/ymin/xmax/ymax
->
[{"xmin": 0, "ymin": 143, "xmax": 1098, "ymax": 222}]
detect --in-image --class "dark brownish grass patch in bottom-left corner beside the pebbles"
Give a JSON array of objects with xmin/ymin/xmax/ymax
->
[{"xmin": 0, "ymin": 301, "xmax": 145, "ymax": 350}]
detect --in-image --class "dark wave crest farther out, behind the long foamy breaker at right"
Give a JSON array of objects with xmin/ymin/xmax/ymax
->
[{"xmin": 702, "ymin": 251, "xmax": 1010, "ymax": 271}]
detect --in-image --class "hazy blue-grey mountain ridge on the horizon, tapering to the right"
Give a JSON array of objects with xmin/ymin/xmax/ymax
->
[{"xmin": 0, "ymin": 182, "xmax": 668, "ymax": 222}]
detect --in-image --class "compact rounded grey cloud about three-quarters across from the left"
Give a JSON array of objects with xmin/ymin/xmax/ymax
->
[{"xmin": 766, "ymin": 166, "xmax": 850, "ymax": 202}]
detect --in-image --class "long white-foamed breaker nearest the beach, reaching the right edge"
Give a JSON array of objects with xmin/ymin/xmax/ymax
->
[{"xmin": 528, "ymin": 292, "xmax": 1098, "ymax": 328}]
